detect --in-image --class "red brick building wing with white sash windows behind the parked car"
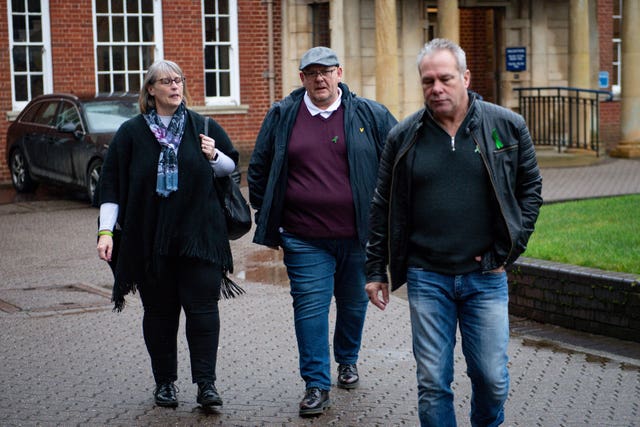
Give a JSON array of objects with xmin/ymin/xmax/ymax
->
[{"xmin": 0, "ymin": 0, "xmax": 281, "ymax": 183}]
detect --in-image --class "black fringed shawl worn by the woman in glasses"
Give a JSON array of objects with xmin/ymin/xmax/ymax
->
[{"xmin": 96, "ymin": 110, "xmax": 239, "ymax": 311}]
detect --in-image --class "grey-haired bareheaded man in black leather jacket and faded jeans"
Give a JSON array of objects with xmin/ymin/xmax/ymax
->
[{"xmin": 366, "ymin": 39, "xmax": 542, "ymax": 426}]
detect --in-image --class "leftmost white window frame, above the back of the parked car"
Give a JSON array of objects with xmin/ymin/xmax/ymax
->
[{"xmin": 7, "ymin": 0, "xmax": 53, "ymax": 111}]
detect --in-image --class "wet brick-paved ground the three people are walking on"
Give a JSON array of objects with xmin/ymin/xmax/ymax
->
[{"xmin": 0, "ymin": 160, "xmax": 640, "ymax": 427}]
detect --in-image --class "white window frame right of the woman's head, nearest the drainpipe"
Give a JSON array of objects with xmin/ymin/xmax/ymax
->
[{"xmin": 201, "ymin": 0, "xmax": 240, "ymax": 106}]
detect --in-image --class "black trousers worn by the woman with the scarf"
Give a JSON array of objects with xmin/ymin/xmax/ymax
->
[{"xmin": 140, "ymin": 257, "xmax": 222, "ymax": 384}]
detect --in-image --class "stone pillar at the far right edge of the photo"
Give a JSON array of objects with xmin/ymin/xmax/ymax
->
[{"xmin": 610, "ymin": 0, "xmax": 640, "ymax": 158}]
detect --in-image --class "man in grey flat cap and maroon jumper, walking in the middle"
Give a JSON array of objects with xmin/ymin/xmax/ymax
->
[{"xmin": 247, "ymin": 46, "xmax": 397, "ymax": 416}]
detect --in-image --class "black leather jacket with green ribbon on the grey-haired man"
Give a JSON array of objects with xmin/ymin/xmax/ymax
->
[{"xmin": 366, "ymin": 93, "xmax": 542, "ymax": 290}]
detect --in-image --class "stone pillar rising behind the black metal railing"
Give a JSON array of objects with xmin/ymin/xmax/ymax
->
[{"xmin": 569, "ymin": 0, "xmax": 591, "ymax": 89}]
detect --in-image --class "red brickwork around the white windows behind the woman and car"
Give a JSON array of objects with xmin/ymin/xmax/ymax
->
[{"xmin": 0, "ymin": 0, "xmax": 282, "ymax": 183}]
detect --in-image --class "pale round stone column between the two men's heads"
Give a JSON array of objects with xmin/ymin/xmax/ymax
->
[{"xmin": 375, "ymin": 0, "xmax": 400, "ymax": 117}]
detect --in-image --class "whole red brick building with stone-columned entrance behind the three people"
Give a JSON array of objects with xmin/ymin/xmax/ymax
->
[{"xmin": 0, "ymin": 0, "xmax": 640, "ymax": 183}]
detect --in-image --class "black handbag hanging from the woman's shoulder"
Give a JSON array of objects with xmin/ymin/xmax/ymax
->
[{"xmin": 204, "ymin": 117, "xmax": 252, "ymax": 240}]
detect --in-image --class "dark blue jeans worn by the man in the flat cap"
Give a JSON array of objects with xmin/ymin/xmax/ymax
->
[{"xmin": 281, "ymin": 232, "xmax": 369, "ymax": 390}]
